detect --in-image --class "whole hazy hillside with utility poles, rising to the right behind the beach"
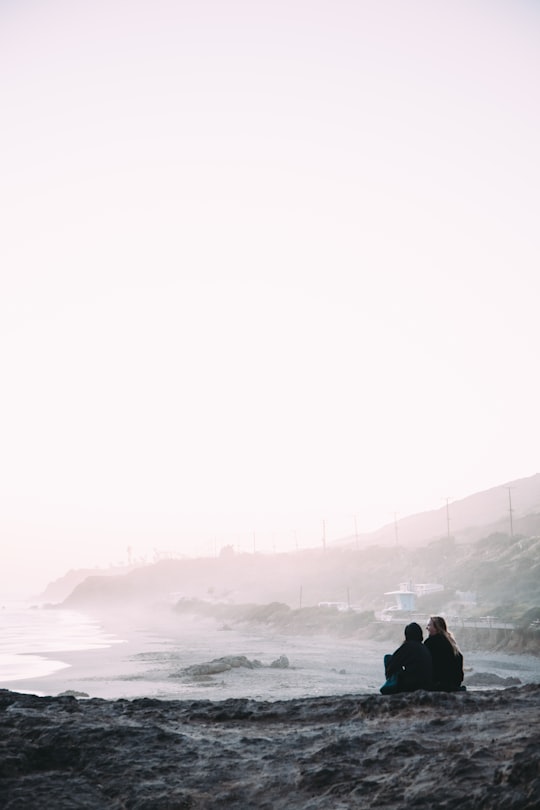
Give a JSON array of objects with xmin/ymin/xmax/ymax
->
[{"xmin": 47, "ymin": 475, "xmax": 540, "ymax": 624}]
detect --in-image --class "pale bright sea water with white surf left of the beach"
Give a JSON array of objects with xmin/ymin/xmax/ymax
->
[{"xmin": 0, "ymin": 597, "xmax": 121, "ymax": 685}]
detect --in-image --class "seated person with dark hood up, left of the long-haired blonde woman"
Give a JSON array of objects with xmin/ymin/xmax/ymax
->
[{"xmin": 380, "ymin": 622, "xmax": 432, "ymax": 695}]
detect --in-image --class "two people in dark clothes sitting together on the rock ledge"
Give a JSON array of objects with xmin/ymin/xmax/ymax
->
[{"xmin": 380, "ymin": 616, "xmax": 465, "ymax": 695}]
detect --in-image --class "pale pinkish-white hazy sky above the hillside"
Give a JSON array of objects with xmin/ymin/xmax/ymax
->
[{"xmin": 0, "ymin": 0, "xmax": 540, "ymax": 590}]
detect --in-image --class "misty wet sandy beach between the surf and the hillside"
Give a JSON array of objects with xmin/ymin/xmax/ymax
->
[{"xmin": 4, "ymin": 610, "xmax": 540, "ymax": 700}]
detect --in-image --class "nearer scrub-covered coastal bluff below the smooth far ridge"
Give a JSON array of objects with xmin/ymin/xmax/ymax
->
[{"xmin": 59, "ymin": 533, "xmax": 540, "ymax": 621}]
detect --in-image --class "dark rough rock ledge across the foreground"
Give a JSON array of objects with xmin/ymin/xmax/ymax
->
[{"xmin": 0, "ymin": 685, "xmax": 540, "ymax": 810}]
